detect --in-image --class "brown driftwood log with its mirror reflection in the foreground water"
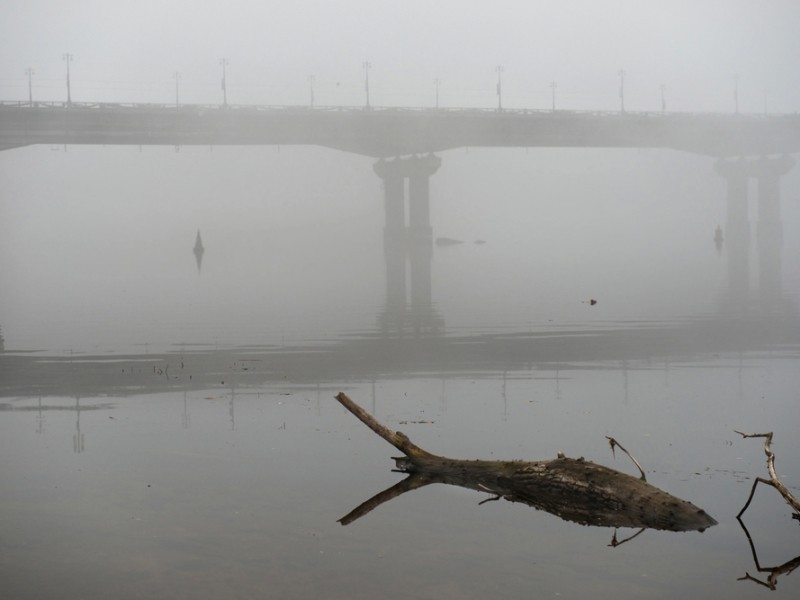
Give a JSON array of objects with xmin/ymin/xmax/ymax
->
[{"xmin": 336, "ymin": 393, "xmax": 716, "ymax": 531}]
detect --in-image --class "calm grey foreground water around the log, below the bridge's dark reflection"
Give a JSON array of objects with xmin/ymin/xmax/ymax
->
[{"xmin": 0, "ymin": 346, "xmax": 800, "ymax": 598}]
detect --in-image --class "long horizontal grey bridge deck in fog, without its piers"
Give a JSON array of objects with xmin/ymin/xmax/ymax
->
[{"xmin": 0, "ymin": 101, "xmax": 800, "ymax": 158}]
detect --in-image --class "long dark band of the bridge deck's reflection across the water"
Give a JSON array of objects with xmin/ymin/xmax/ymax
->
[{"xmin": 0, "ymin": 313, "xmax": 800, "ymax": 398}]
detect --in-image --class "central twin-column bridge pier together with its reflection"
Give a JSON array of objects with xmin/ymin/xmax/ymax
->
[{"xmin": 373, "ymin": 154, "xmax": 442, "ymax": 332}]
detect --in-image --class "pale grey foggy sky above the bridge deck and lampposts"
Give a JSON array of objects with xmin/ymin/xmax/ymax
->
[{"xmin": 0, "ymin": 0, "xmax": 800, "ymax": 112}]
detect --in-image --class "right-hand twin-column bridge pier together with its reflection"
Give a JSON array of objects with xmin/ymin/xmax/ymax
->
[{"xmin": 714, "ymin": 156, "xmax": 795, "ymax": 310}]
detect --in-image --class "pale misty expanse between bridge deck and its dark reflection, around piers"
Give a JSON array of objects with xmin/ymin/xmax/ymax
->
[{"xmin": 0, "ymin": 141, "xmax": 798, "ymax": 351}]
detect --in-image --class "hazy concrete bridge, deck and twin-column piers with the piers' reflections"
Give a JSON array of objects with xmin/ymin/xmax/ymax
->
[{"xmin": 0, "ymin": 102, "xmax": 800, "ymax": 332}]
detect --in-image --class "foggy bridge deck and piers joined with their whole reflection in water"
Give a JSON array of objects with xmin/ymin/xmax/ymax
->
[{"xmin": 0, "ymin": 105, "xmax": 800, "ymax": 396}]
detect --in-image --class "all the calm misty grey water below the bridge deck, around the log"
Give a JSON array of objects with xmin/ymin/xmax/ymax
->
[{"xmin": 0, "ymin": 148, "xmax": 800, "ymax": 599}]
